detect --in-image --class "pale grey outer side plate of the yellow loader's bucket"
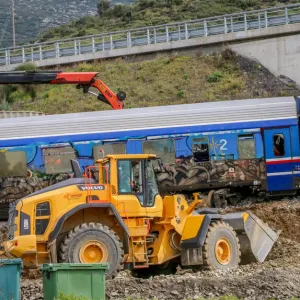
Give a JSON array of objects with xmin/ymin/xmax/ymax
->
[{"xmin": 244, "ymin": 211, "xmax": 279, "ymax": 262}]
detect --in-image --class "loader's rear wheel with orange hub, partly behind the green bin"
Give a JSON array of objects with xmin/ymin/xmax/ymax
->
[{"xmin": 59, "ymin": 223, "xmax": 124, "ymax": 278}]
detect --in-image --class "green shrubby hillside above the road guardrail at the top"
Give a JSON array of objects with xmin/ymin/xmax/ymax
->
[{"xmin": 38, "ymin": 0, "xmax": 299, "ymax": 41}]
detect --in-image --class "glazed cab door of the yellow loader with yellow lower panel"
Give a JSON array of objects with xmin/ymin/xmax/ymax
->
[{"xmin": 117, "ymin": 160, "xmax": 162, "ymax": 217}]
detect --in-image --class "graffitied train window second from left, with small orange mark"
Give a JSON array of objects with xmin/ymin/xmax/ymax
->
[{"xmin": 44, "ymin": 147, "xmax": 76, "ymax": 174}]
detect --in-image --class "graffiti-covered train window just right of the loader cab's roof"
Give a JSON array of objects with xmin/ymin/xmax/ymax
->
[{"xmin": 143, "ymin": 139, "xmax": 176, "ymax": 165}]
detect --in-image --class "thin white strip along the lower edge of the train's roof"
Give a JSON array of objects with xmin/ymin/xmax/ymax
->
[{"xmin": 0, "ymin": 117, "xmax": 295, "ymax": 142}]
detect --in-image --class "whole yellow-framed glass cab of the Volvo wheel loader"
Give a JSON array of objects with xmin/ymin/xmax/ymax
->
[{"xmin": 103, "ymin": 154, "xmax": 163, "ymax": 217}]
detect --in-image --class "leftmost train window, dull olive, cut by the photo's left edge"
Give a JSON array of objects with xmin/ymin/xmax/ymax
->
[{"xmin": 0, "ymin": 151, "xmax": 27, "ymax": 177}]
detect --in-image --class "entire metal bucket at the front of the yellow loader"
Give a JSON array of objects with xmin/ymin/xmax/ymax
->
[{"xmin": 222, "ymin": 211, "xmax": 279, "ymax": 263}]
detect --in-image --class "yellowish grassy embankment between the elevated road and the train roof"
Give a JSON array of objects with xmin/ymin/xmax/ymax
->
[{"xmin": 5, "ymin": 52, "xmax": 299, "ymax": 114}]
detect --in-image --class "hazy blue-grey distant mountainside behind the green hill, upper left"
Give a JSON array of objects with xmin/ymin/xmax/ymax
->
[{"xmin": 0, "ymin": 0, "xmax": 134, "ymax": 48}]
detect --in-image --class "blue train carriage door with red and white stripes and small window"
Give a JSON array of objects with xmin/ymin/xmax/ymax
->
[{"xmin": 264, "ymin": 128, "xmax": 293, "ymax": 191}]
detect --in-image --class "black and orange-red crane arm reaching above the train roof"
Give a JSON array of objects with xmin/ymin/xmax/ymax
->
[{"xmin": 0, "ymin": 71, "xmax": 126, "ymax": 110}]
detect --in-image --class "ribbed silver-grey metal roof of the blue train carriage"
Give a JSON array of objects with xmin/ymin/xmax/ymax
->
[{"xmin": 0, "ymin": 97, "xmax": 297, "ymax": 139}]
